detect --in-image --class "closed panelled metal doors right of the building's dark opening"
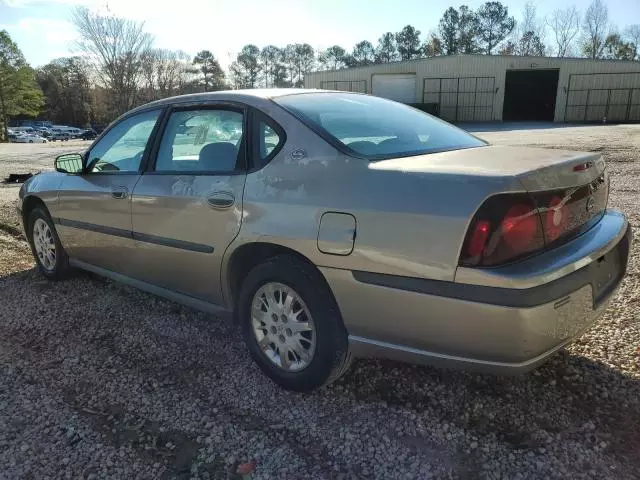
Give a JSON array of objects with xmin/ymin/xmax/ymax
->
[{"xmin": 564, "ymin": 72, "xmax": 640, "ymax": 122}]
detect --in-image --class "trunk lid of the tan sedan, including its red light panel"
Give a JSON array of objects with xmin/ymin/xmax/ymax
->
[{"xmin": 371, "ymin": 146, "xmax": 609, "ymax": 258}]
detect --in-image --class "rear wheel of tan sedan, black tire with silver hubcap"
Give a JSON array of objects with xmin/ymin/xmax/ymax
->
[{"xmin": 238, "ymin": 255, "xmax": 349, "ymax": 392}]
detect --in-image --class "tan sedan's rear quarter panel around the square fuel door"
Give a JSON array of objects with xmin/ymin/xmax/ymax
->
[{"xmin": 223, "ymin": 98, "xmax": 524, "ymax": 300}]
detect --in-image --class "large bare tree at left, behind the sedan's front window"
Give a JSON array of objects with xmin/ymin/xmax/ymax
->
[{"xmin": 73, "ymin": 7, "xmax": 153, "ymax": 114}]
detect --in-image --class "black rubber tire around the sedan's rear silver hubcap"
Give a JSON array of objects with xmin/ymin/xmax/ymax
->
[{"xmin": 237, "ymin": 255, "xmax": 350, "ymax": 392}]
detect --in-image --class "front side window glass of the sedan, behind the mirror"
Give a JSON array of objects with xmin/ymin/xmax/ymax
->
[{"xmin": 87, "ymin": 110, "xmax": 160, "ymax": 172}]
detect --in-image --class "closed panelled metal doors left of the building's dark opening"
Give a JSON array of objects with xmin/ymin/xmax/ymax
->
[{"xmin": 422, "ymin": 77, "xmax": 496, "ymax": 122}]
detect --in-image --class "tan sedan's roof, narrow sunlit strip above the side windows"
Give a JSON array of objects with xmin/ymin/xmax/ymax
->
[{"xmin": 126, "ymin": 88, "xmax": 349, "ymax": 115}]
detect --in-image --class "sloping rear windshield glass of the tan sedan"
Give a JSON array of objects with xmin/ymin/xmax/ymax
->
[{"xmin": 274, "ymin": 93, "xmax": 486, "ymax": 160}]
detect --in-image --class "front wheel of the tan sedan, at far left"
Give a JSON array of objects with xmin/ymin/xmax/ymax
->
[{"xmin": 27, "ymin": 207, "xmax": 69, "ymax": 280}]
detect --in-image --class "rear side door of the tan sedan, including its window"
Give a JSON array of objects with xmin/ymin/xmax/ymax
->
[{"xmin": 132, "ymin": 104, "xmax": 247, "ymax": 304}]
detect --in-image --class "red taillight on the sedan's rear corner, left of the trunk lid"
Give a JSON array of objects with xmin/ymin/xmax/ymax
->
[{"xmin": 460, "ymin": 194, "xmax": 544, "ymax": 266}]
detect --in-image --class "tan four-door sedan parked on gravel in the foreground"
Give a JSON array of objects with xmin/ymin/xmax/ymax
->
[{"xmin": 18, "ymin": 89, "xmax": 631, "ymax": 391}]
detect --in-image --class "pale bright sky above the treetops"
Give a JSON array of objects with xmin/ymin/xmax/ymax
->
[{"xmin": 0, "ymin": 0, "xmax": 640, "ymax": 66}]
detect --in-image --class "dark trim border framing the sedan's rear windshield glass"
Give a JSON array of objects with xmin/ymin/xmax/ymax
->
[{"xmin": 271, "ymin": 92, "xmax": 489, "ymax": 162}]
